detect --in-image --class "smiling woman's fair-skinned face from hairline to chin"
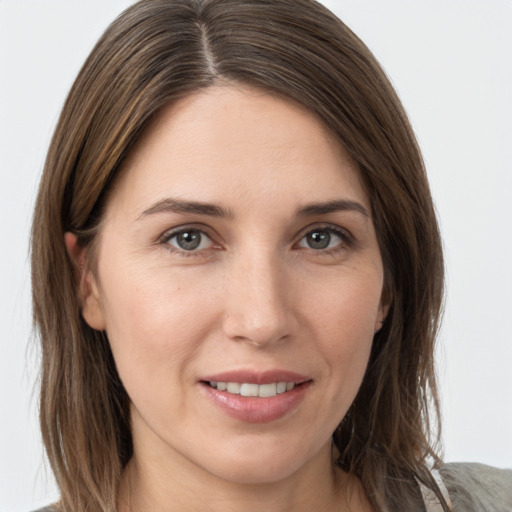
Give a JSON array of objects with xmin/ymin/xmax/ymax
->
[{"xmin": 83, "ymin": 86, "xmax": 385, "ymax": 483}]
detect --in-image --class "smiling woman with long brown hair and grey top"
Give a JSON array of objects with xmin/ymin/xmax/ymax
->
[{"xmin": 32, "ymin": 0, "xmax": 510, "ymax": 512}]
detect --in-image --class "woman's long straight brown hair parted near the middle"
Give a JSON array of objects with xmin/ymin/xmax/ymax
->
[{"xmin": 32, "ymin": 0, "xmax": 448, "ymax": 512}]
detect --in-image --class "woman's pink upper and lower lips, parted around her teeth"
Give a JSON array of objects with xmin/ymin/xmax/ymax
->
[{"xmin": 198, "ymin": 370, "xmax": 312, "ymax": 423}]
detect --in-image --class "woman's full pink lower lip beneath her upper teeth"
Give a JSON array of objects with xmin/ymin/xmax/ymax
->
[{"xmin": 201, "ymin": 381, "xmax": 311, "ymax": 423}]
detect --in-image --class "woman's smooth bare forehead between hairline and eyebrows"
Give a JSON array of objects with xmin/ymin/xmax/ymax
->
[{"xmin": 110, "ymin": 86, "xmax": 369, "ymax": 217}]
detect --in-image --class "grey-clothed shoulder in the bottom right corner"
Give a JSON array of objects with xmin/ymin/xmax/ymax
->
[{"xmin": 440, "ymin": 463, "xmax": 512, "ymax": 512}]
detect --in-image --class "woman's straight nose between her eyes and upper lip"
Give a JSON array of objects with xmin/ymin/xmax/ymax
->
[{"xmin": 223, "ymin": 255, "xmax": 293, "ymax": 347}]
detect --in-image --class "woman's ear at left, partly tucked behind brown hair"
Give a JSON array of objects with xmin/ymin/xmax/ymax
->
[{"xmin": 64, "ymin": 232, "xmax": 106, "ymax": 331}]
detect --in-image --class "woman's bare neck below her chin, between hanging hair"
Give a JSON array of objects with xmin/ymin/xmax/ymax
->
[{"xmin": 119, "ymin": 446, "xmax": 372, "ymax": 512}]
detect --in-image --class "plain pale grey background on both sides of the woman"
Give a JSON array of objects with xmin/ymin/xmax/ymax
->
[{"xmin": 0, "ymin": 0, "xmax": 512, "ymax": 512}]
